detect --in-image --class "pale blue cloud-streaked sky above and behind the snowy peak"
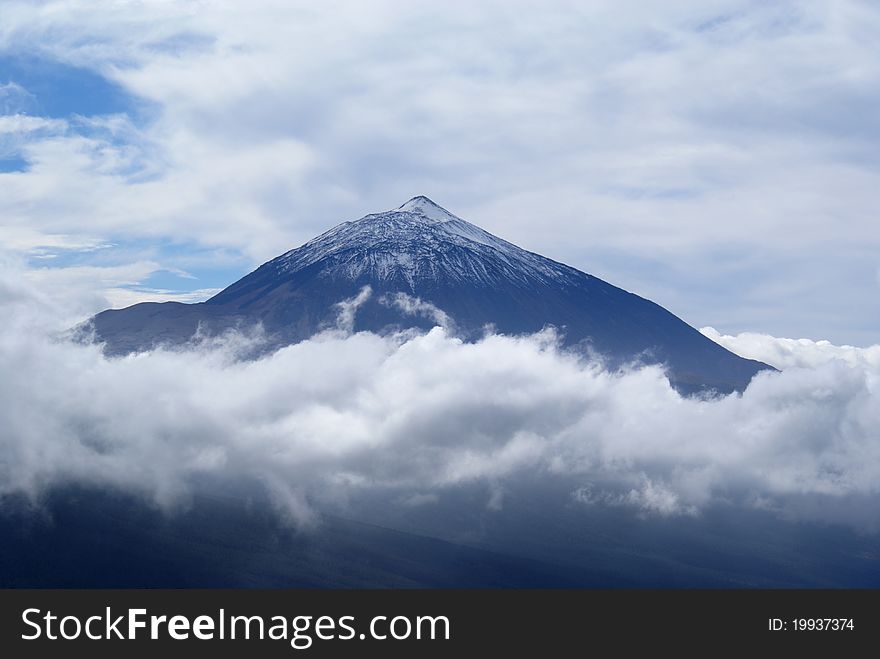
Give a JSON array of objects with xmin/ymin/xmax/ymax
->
[{"xmin": 0, "ymin": 0, "xmax": 880, "ymax": 340}]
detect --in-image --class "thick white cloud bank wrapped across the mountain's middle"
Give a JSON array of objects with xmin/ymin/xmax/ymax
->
[{"xmin": 0, "ymin": 273, "xmax": 880, "ymax": 527}]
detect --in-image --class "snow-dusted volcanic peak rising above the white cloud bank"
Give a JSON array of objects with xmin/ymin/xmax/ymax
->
[{"xmin": 92, "ymin": 196, "xmax": 770, "ymax": 392}]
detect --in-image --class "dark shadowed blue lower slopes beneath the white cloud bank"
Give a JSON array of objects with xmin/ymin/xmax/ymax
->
[{"xmin": 8, "ymin": 474, "xmax": 880, "ymax": 589}]
